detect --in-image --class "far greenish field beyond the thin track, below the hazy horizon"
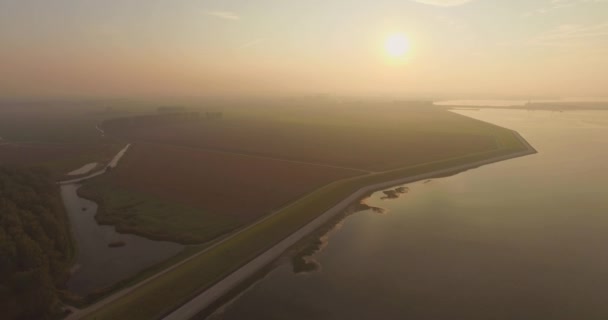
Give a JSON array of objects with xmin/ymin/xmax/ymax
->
[{"xmin": 103, "ymin": 106, "xmax": 497, "ymax": 171}]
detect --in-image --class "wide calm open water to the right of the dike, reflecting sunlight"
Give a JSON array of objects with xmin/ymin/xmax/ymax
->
[{"xmin": 212, "ymin": 110, "xmax": 608, "ymax": 320}]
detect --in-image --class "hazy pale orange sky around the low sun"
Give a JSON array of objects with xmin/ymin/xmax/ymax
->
[{"xmin": 0, "ymin": 0, "xmax": 608, "ymax": 99}]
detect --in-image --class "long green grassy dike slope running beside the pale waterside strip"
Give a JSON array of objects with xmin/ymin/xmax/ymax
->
[{"xmin": 85, "ymin": 116, "xmax": 525, "ymax": 320}]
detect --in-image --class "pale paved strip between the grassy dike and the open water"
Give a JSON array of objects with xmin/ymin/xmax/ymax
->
[{"xmin": 162, "ymin": 130, "xmax": 538, "ymax": 320}]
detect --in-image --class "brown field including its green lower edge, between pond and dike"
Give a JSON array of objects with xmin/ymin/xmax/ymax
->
[{"xmin": 82, "ymin": 143, "xmax": 361, "ymax": 243}]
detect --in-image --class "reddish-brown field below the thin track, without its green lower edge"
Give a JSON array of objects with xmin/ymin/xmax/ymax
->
[{"xmin": 108, "ymin": 143, "xmax": 361, "ymax": 221}]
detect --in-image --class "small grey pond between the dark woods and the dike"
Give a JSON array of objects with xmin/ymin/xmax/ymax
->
[{"xmin": 61, "ymin": 184, "xmax": 183, "ymax": 294}]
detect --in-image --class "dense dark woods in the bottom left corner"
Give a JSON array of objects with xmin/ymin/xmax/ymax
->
[{"xmin": 0, "ymin": 166, "xmax": 74, "ymax": 319}]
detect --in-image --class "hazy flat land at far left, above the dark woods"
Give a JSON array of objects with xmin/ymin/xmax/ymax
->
[{"xmin": 0, "ymin": 108, "xmax": 121, "ymax": 179}]
